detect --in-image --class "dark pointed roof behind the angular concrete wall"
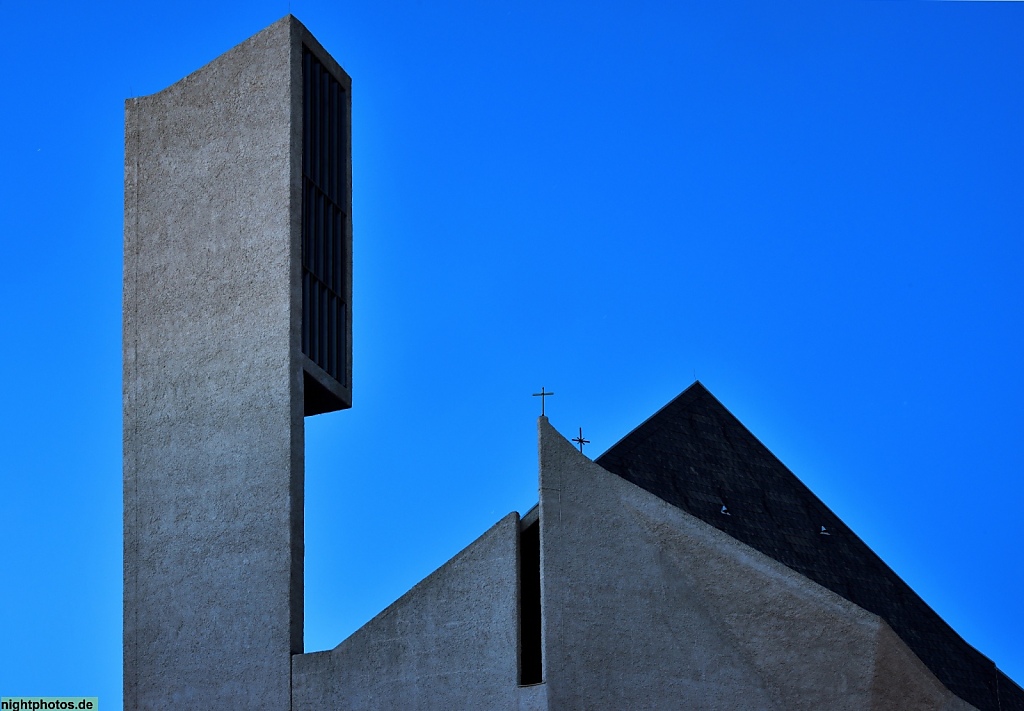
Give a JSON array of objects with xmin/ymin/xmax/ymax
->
[{"xmin": 596, "ymin": 382, "xmax": 1024, "ymax": 711}]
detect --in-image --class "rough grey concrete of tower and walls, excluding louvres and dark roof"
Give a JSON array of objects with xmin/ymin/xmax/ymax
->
[{"xmin": 124, "ymin": 11, "xmax": 987, "ymax": 711}]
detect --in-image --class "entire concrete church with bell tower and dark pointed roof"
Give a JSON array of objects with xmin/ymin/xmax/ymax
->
[{"xmin": 123, "ymin": 16, "xmax": 1024, "ymax": 711}]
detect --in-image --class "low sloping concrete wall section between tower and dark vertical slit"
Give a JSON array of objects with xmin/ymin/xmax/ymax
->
[{"xmin": 292, "ymin": 513, "xmax": 520, "ymax": 711}]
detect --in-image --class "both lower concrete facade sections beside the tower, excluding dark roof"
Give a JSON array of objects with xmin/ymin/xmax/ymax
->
[{"xmin": 284, "ymin": 417, "xmax": 987, "ymax": 711}]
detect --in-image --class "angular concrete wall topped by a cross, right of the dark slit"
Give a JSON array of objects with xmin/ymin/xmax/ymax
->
[{"xmin": 540, "ymin": 418, "xmax": 971, "ymax": 711}]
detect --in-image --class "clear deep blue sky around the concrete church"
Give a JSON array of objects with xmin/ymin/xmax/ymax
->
[{"xmin": 0, "ymin": 0, "xmax": 1024, "ymax": 709}]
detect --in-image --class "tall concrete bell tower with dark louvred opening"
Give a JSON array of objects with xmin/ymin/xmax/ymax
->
[{"xmin": 124, "ymin": 16, "xmax": 352, "ymax": 711}]
